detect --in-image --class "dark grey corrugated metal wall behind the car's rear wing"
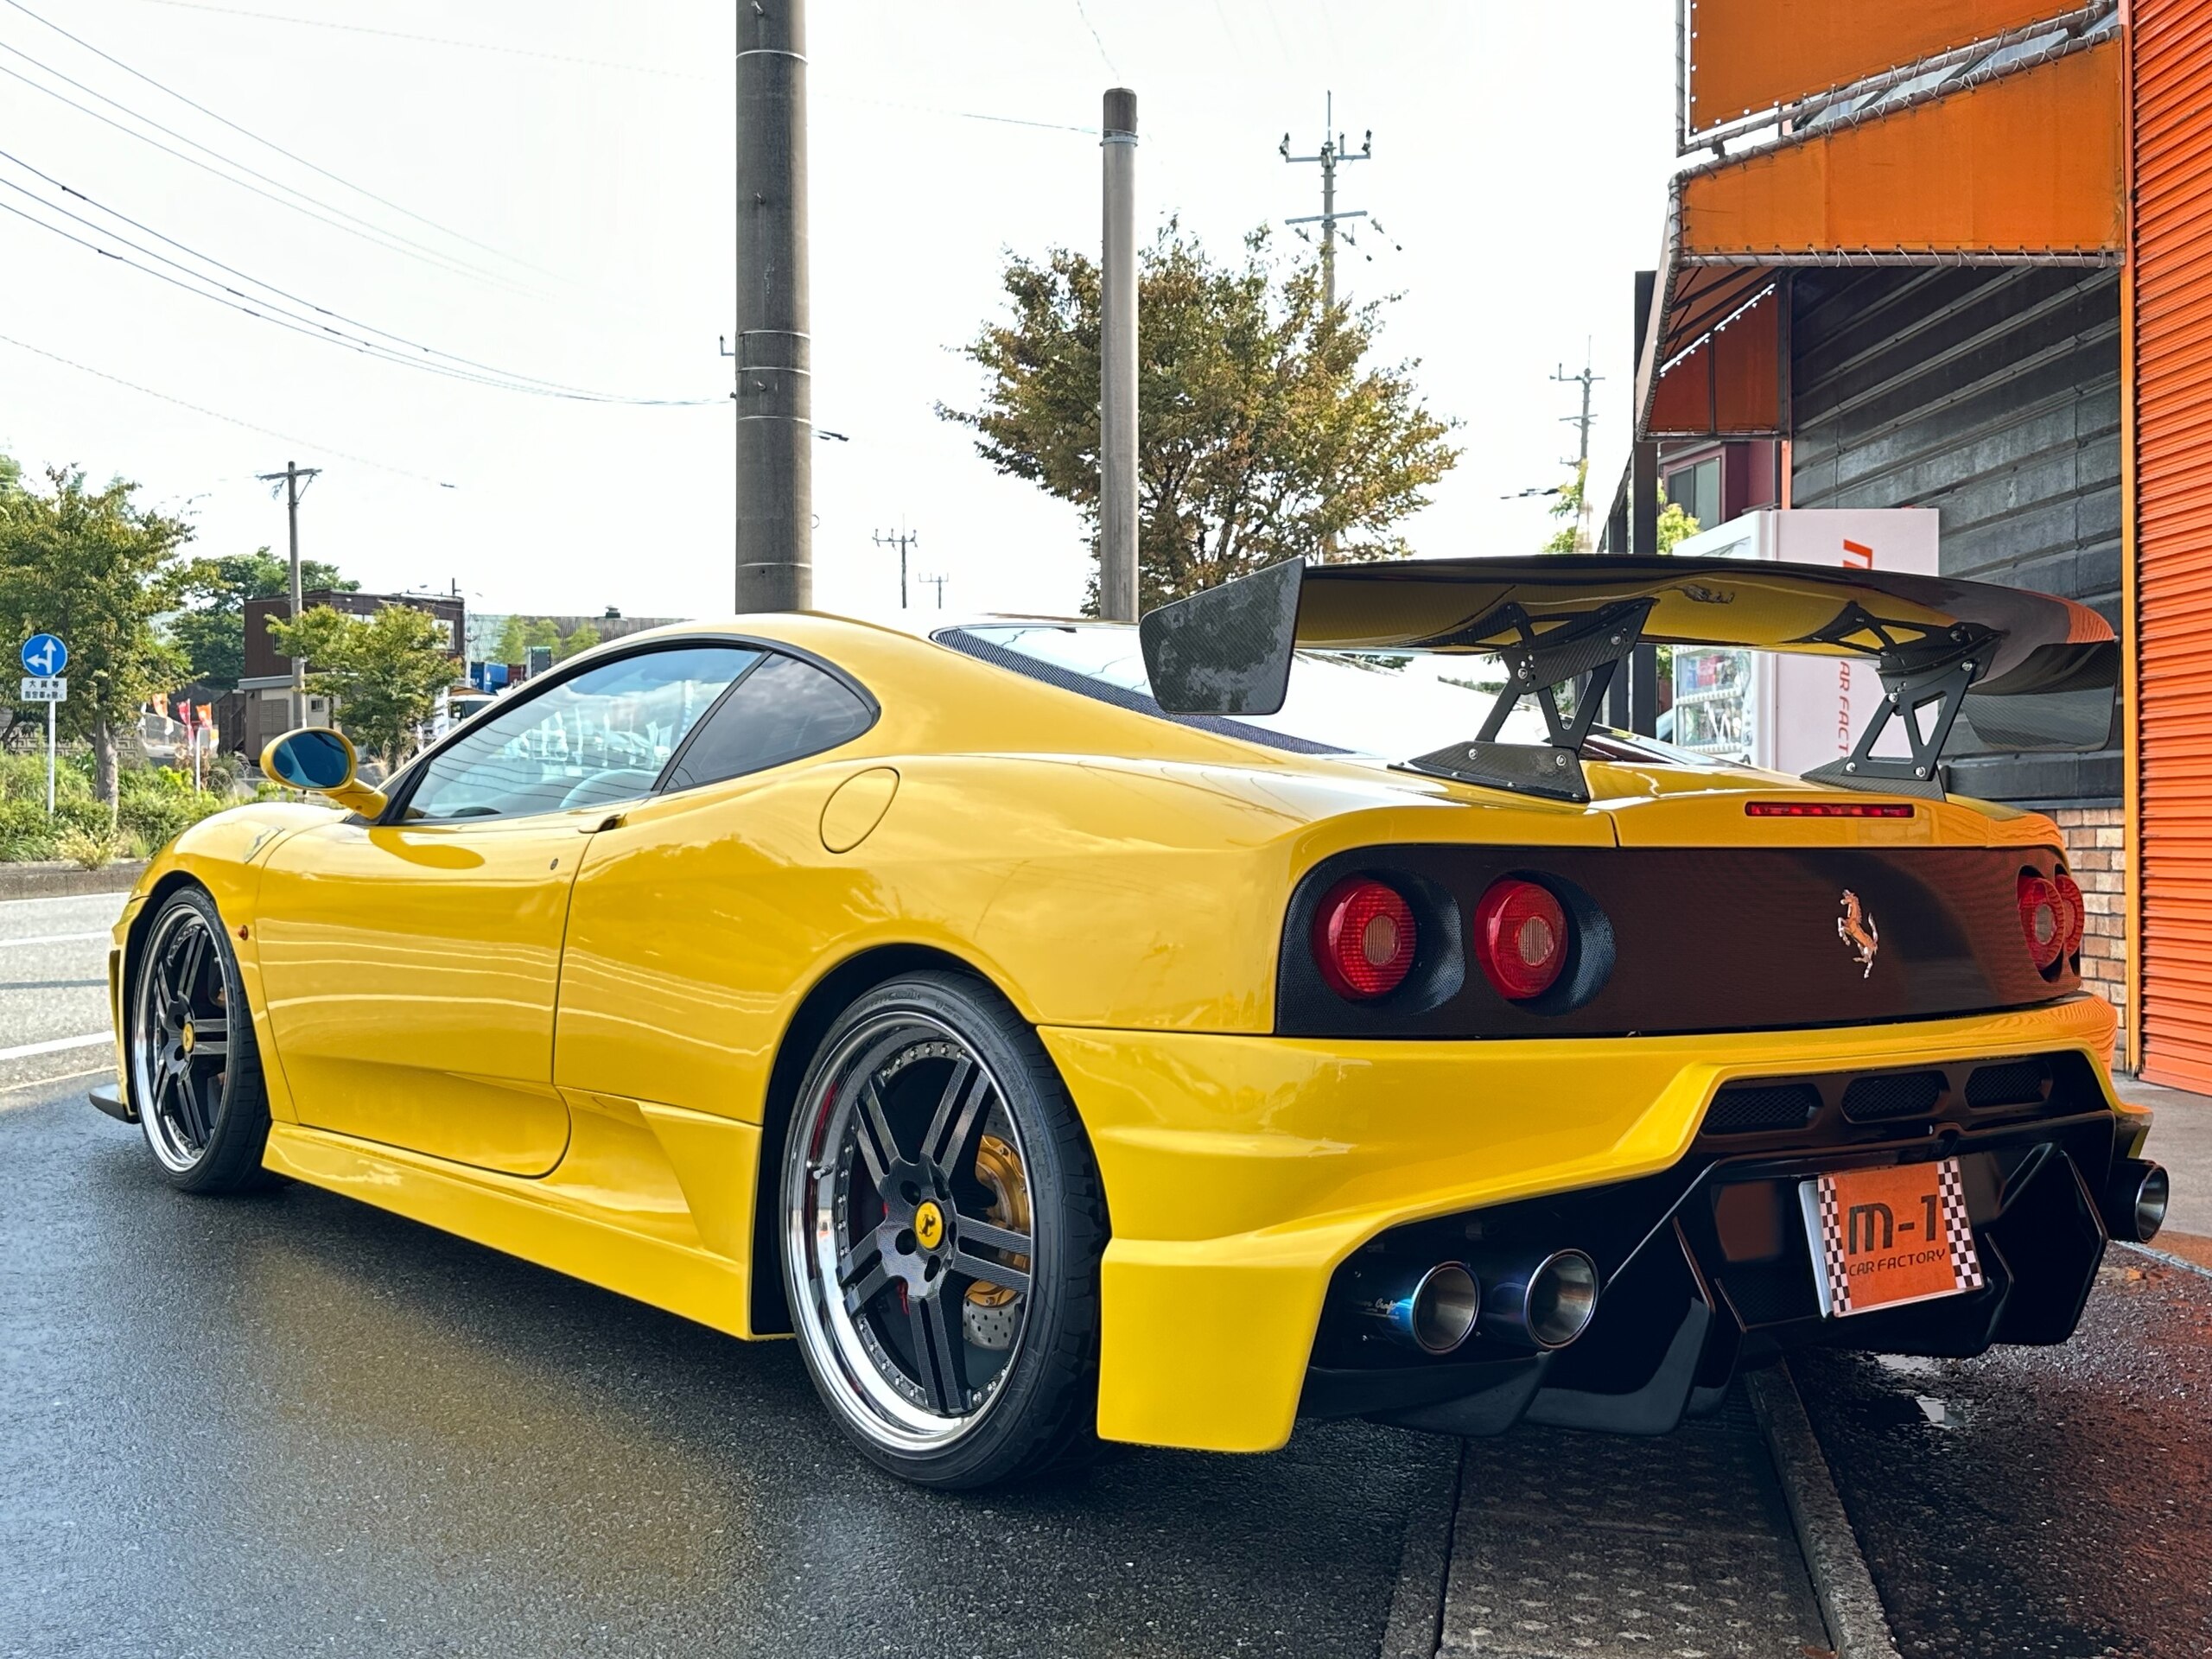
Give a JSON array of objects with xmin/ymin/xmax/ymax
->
[{"xmin": 1789, "ymin": 265, "xmax": 2121, "ymax": 803}]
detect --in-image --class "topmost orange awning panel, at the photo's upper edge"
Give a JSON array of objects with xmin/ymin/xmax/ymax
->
[{"xmin": 1686, "ymin": 0, "xmax": 2073, "ymax": 137}]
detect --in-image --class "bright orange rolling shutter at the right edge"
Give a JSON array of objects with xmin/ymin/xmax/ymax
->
[{"xmin": 2133, "ymin": 0, "xmax": 2212, "ymax": 1093}]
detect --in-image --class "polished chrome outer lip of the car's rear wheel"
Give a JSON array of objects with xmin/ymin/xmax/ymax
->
[{"xmin": 783, "ymin": 1008, "xmax": 1039, "ymax": 1453}]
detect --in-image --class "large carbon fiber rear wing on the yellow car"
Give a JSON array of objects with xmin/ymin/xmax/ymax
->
[{"xmin": 1139, "ymin": 557, "xmax": 2119, "ymax": 801}]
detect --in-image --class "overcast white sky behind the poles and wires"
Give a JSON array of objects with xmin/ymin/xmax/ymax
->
[{"xmin": 0, "ymin": 0, "xmax": 1675, "ymax": 615}]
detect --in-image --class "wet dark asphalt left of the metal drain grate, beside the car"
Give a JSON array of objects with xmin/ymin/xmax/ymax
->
[{"xmin": 0, "ymin": 1082, "xmax": 1458, "ymax": 1659}]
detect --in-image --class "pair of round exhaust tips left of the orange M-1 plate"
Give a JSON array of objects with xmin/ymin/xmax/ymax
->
[{"xmin": 1351, "ymin": 1249, "xmax": 1597, "ymax": 1356}]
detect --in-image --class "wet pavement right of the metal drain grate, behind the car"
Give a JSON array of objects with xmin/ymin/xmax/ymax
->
[{"xmin": 1792, "ymin": 1245, "xmax": 2212, "ymax": 1659}]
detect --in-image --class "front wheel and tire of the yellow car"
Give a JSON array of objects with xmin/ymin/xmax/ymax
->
[{"xmin": 124, "ymin": 887, "xmax": 274, "ymax": 1194}]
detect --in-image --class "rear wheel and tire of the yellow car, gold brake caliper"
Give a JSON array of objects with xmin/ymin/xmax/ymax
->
[{"xmin": 777, "ymin": 971, "xmax": 1109, "ymax": 1491}]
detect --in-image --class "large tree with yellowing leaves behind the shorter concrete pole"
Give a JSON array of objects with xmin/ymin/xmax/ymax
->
[{"xmin": 938, "ymin": 221, "xmax": 1460, "ymax": 606}]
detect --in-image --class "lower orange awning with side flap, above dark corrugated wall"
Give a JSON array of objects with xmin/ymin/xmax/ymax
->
[{"xmin": 1637, "ymin": 35, "xmax": 2126, "ymax": 438}]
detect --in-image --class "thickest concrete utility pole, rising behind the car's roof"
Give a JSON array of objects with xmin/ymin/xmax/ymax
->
[{"xmin": 734, "ymin": 0, "xmax": 814, "ymax": 611}]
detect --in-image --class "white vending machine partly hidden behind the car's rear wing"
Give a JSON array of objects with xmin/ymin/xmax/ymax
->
[{"xmin": 1672, "ymin": 506, "xmax": 1936, "ymax": 772}]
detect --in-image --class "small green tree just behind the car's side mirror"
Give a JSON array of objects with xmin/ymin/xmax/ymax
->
[{"xmin": 270, "ymin": 604, "xmax": 455, "ymax": 766}]
